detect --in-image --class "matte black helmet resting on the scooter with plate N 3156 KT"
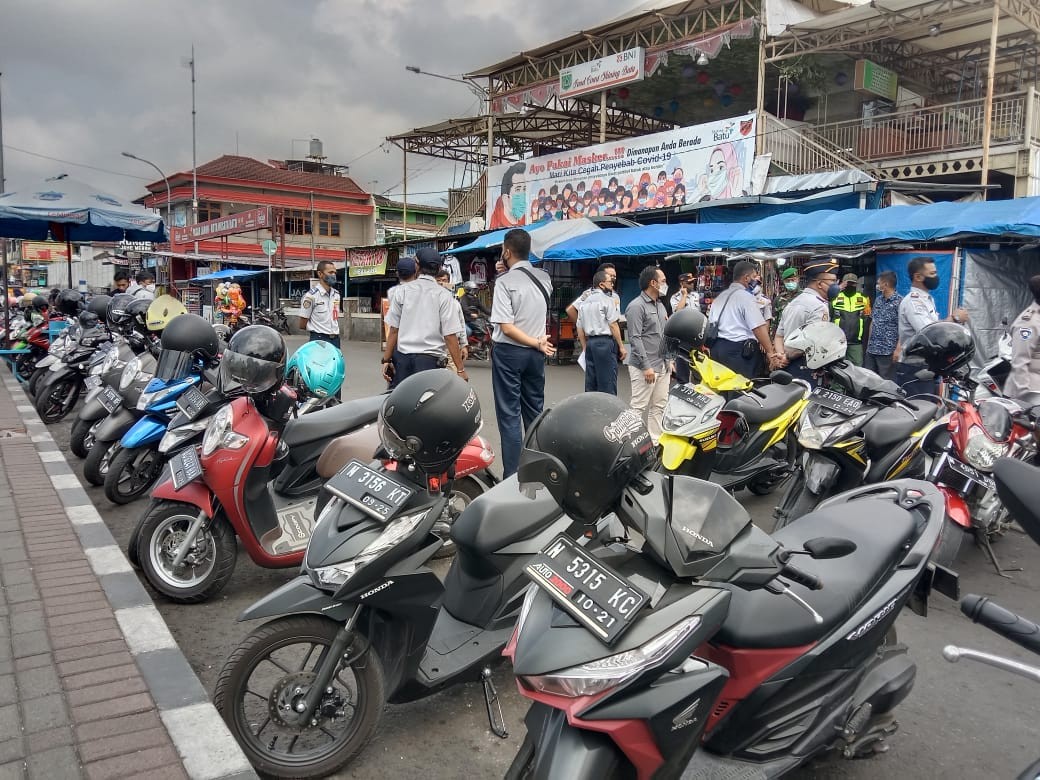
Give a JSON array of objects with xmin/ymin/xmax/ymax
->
[{"xmin": 380, "ymin": 368, "xmax": 483, "ymax": 475}]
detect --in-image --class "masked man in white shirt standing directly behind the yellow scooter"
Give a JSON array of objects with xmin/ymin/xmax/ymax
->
[{"xmin": 708, "ymin": 260, "xmax": 780, "ymax": 379}]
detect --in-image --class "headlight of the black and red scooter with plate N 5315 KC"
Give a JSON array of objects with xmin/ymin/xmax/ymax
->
[{"xmin": 519, "ymin": 615, "xmax": 701, "ymax": 699}]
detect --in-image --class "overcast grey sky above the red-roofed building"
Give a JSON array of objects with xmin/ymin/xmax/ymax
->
[{"xmin": 0, "ymin": 0, "xmax": 638, "ymax": 203}]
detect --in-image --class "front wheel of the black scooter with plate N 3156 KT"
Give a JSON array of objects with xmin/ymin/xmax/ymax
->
[{"xmin": 213, "ymin": 616, "xmax": 386, "ymax": 778}]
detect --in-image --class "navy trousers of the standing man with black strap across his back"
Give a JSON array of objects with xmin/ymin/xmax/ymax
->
[{"xmin": 491, "ymin": 342, "xmax": 545, "ymax": 477}]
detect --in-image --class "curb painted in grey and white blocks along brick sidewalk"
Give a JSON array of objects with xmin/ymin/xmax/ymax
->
[{"xmin": 3, "ymin": 372, "xmax": 257, "ymax": 780}]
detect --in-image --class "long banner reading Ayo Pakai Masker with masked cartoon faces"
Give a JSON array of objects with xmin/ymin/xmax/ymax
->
[{"xmin": 487, "ymin": 113, "xmax": 760, "ymax": 230}]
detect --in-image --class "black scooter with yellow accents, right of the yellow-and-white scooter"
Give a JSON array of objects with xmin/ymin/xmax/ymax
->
[{"xmin": 774, "ymin": 359, "xmax": 941, "ymax": 530}]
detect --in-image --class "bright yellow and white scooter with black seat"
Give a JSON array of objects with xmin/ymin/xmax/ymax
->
[{"xmin": 659, "ymin": 350, "xmax": 809, "ymax": 495}]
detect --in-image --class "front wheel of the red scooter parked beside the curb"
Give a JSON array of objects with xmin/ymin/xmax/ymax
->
[{"xmin": 130, "ymin": 501, "xmax": 238, "ymax": 604}]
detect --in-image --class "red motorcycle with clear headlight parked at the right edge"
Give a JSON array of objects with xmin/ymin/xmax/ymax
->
[{"xmin": 922, "ymin": 368, "xmax": 1040, "ymax": 576}]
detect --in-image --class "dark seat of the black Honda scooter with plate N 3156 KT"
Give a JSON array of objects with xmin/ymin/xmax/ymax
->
[{"xmin": 451, "ymin": 476, "xmax": 561, "ymax": 556}]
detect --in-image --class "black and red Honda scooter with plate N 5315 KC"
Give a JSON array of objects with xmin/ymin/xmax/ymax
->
[{"xmin": 505, "ymin": 466, "xmax": 956, "ymax": 780}]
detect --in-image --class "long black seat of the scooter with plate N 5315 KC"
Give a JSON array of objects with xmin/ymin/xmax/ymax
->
[{"xmin": 712, "ymin": 498, "xmax": 917, "ymax": 649}]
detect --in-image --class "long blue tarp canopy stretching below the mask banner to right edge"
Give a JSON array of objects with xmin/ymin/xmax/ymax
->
[{"xmin": 543, "ymin": 198, "xmax": 1040, "ymax": 260}]
